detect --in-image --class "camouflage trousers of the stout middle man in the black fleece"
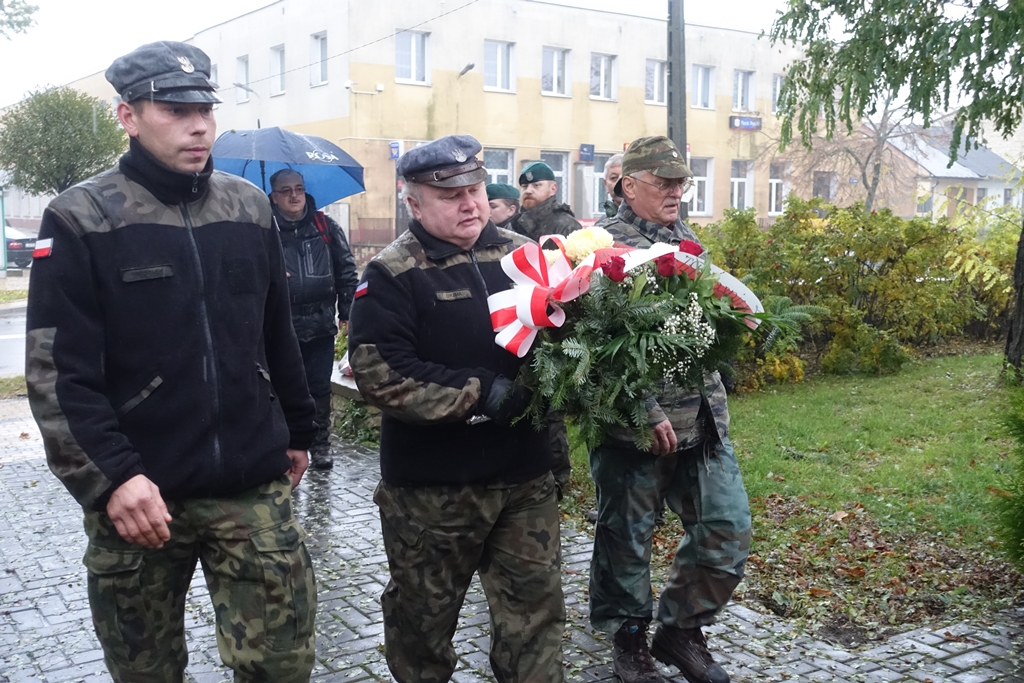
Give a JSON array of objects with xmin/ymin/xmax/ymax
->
[{"xmin": 374, "ymin": 473, "xmax": 565, "ymax": 683}]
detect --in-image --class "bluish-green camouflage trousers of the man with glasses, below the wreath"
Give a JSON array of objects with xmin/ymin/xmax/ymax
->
[{"xmin": 590, "ymin": 439, "xmax": 751, "ymax": 633}]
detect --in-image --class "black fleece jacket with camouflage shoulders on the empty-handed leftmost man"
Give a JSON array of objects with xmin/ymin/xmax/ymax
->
[{"xmin": 26, "ymin": 140, "xmax": 315, "ymax": 510}]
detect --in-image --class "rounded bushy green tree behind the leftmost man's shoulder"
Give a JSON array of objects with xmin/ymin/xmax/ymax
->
[{"xmin": 0, "ymin": 87, "xmax": 128, "ymax": 195}]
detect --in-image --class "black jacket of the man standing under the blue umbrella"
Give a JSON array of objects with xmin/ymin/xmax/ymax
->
[{"xmin": 273, "ymin": 193, "xmax": 358, "ymax": 342}]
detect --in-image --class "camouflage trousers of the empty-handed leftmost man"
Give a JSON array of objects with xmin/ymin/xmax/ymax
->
[{"xmin": 85, "ymin": 476, "xmax": 316, "ymax": 683}]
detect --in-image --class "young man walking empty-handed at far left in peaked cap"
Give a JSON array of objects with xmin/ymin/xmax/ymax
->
[{"xmin": 26, "ymin": 42, "xmax": 316, "ymax": 683}]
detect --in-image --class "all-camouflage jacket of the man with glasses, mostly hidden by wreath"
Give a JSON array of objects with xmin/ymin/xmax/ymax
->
[{"xmin": 599, "ymin": 202, "xmax": 729, "ymax": 449}]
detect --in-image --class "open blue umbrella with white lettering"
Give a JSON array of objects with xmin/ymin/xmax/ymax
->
[{"xmin": 213, "ymin": 127, "xmax": 366, "ymax": 209}]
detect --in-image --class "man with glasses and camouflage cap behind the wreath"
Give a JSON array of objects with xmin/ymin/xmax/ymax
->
[{"xmin": 590, "ymin": 136, "xmax": 751, "ymax": 683}]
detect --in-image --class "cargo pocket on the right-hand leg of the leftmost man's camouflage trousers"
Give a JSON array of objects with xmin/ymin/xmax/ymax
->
[{"xmin": 249, "ymin": 519, "xmax": 316, "ymax": 650}]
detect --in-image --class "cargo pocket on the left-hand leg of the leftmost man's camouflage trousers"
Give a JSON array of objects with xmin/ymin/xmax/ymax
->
[{"xmin": 83, "ymin": 544, "xmax": 149, "ymax": 666}]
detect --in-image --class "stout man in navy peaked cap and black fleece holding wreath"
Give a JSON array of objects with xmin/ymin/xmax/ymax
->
[{"xmin": 349, "ymin": 135, "xmax": 565, "ymax": 683}]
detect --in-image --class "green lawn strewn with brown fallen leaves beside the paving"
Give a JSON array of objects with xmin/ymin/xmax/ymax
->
[{"xmin": 563, "ymin": 353, "xmax": 1024, "ymax": 645}]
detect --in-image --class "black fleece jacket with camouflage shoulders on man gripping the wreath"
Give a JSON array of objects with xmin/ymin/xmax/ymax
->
[{"xmin": 349, "ymin": 220, "xmax": 551, "ymax": 485}]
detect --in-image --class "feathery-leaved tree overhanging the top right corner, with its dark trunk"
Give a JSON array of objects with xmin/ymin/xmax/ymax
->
[{"xmin": 770, "ymin": 0, "xmax": 1024, "ymax": 377}]
